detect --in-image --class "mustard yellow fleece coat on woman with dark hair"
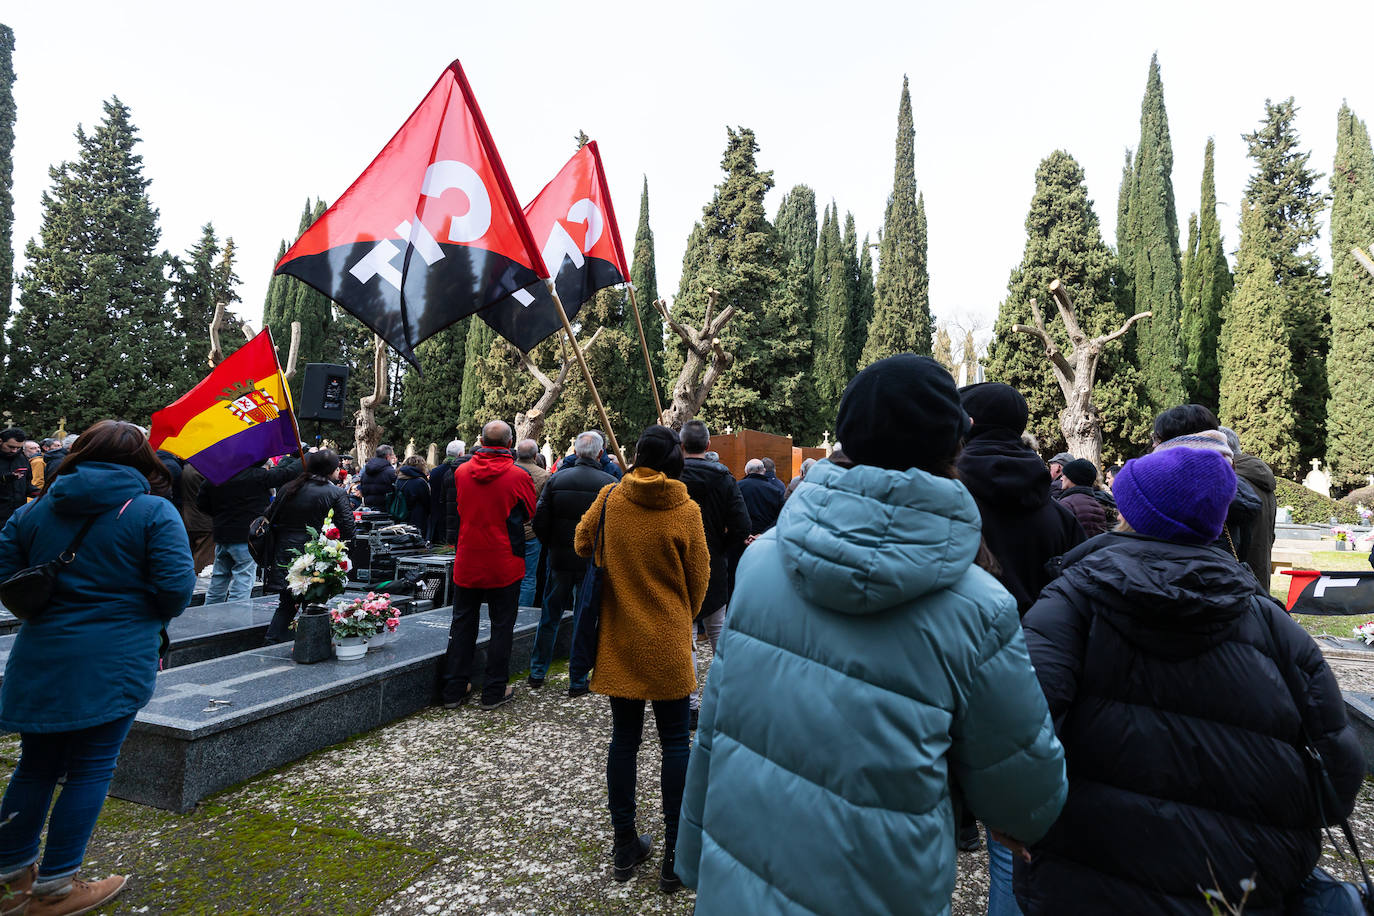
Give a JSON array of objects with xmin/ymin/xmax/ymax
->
[{"xmin": 574, "ymin": 468, "xmax": 710, "ymax": 700}]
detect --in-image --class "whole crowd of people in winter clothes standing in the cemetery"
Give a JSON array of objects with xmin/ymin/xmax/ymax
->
[{"xmin": 0, "ymin": 348, "xmax": 1364, "ymax": 916}]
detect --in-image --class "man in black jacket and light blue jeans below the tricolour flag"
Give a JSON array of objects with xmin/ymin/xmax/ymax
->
[{"xmin": 195, "ymin": 459, "xmax": 301, "ymax": 604}]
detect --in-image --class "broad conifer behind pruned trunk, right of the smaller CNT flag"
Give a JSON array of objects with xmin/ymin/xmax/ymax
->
[{"xmin": 666, "ymin": 128, "xmax": 820, "ymax": 439}]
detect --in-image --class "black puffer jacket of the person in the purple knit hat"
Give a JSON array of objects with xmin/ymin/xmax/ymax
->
[{"xmin": 1015, "ymin": 531, "xmax": 1364, "ymax": 916}]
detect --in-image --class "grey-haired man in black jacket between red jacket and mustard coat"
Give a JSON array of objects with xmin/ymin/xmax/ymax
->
[{"xmin": 529, "ymin": 431, "xmax": 616, "ymax": 696}]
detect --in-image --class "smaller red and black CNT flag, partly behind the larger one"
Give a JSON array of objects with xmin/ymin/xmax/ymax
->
[{"xmin": 478, "ymin": 140, "xmax": 629, "ymax": 353}]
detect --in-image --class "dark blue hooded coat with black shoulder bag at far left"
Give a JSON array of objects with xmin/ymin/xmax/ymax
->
[{"xmin": 0, "ymin": 461, "xmax": 195, "ymax": 732}]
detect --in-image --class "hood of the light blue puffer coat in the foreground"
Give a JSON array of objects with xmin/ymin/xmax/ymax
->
[{"xmin": 765, "ymin": 461, "xmax": 982, "ymax": 614}]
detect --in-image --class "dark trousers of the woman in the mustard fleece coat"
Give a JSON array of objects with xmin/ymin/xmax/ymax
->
[{"xmin": 606, "ymin": 696, "xmax": 691, "ymax": 849}]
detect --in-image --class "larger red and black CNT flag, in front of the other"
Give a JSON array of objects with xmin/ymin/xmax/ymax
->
[{"xmin": 276, "ymin": 60, "xmax": 548, "ymax": 363}]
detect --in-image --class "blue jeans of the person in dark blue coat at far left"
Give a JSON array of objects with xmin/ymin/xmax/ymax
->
[{"xmin": 0, "ymin": 713, "xmax": 133, "ymax": 880}]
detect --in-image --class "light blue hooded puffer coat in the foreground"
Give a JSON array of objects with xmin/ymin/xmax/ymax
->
[{"xmin": 676, "ymin": 461, "xmax": 1066, "ymax": 916}]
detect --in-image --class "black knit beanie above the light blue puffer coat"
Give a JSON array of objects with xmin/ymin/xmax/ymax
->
[{"xmin": 835, "ymin": 353, "xmax": 969, "ymax": 471}]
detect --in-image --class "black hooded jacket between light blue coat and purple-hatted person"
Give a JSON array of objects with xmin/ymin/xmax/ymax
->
[{"xmin": 959, "ymin": 426, "xmax": 1084, "ymax": 614}]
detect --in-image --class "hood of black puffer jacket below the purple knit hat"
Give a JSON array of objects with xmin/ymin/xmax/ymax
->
[{"xmin": 1063, "ymin": 531, "xmax": 1259, "ymax": 659}]
